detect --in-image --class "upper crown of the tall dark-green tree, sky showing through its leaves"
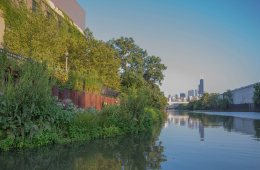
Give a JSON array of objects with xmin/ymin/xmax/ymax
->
[{"xmin": 108, "ymin": 37, "xmax": 166, "ymax": 87}]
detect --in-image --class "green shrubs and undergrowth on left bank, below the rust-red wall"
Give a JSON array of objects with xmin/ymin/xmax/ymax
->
[{"xmin": 0, "ymin": 56, "xmax": 164, "ymax": 150}]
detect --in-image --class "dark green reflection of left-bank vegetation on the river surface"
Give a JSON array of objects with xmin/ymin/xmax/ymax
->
[{"xmin": 0, "ymin": 124, "xmax": 166, "ymax": 170}]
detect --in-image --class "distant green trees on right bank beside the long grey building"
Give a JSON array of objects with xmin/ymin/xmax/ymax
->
[{"xmin": 179, "ymin": 90, "xmax": 233, "ymax": 110}]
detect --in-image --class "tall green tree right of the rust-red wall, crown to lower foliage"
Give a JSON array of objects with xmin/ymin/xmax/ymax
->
[{"xmin": 108, "ymin": 37, "xmax": 167, "ymax": 109}]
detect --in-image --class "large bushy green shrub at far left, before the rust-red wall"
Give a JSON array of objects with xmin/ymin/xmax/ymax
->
[{"xmin": 0, "ymin": 61, "xmax": 72, "ymax": 143}]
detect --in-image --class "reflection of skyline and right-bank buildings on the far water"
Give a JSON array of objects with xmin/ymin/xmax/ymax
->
[{"xmin": 165, "ymin": 112, "xmax": 260, "ymax": 141}]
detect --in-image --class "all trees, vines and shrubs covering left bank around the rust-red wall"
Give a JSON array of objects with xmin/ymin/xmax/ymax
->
[{"xmin": 0, "ymin": 1, "xmax": 167, "ymax": 150}]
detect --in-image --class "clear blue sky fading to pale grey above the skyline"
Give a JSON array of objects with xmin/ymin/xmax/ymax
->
[{"xmin": 78, "ymin": 0, "xmax": 260, "ymax": 95}]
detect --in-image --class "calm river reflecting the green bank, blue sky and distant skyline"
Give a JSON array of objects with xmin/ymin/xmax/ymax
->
[{"xmin": 0, "ymin": 111, "xmax": 260, "ymax": 170}]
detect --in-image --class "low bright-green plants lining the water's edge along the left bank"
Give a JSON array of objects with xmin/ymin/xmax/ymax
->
[{"xmin": 0, "ymin": 102, "xmax": 167, "ymax": 151}]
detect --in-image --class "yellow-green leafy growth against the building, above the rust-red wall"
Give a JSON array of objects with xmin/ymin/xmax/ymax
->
[{"xmin": 0, "ymin": 0, "xmax": 120, "ymax": 92}]
